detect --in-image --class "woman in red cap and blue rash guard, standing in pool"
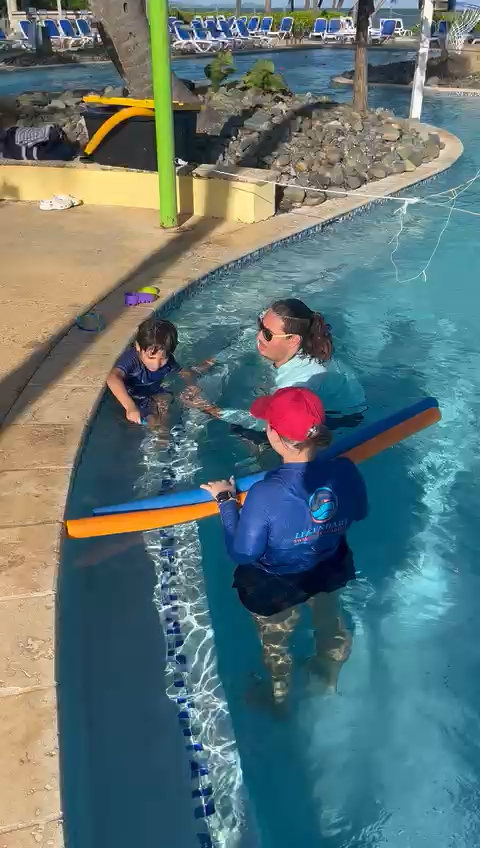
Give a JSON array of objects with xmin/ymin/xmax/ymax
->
[{"xmin": 202, "ymin": 388, "xmax": 368, "ymax": 703}]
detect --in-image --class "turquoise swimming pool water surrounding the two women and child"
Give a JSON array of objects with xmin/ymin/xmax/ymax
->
[{"xmin": 59, "ymin": 71, "xmax": 480, "ymax": 848}]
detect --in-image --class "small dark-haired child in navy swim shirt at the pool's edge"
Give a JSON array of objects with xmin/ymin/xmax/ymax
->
[{"xmin": 107, "ymin": 318, "xmax": 218, "ymax": 427}]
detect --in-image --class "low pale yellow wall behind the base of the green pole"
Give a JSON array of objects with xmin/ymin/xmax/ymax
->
[{"xmin": 0, "ymin": 163, "xmax": 275, "ymax": 224}]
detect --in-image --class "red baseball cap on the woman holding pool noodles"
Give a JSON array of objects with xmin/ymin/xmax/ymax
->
[{"xmin": 250, "ymin": 386, "xmax": 325, "ymax": 442}]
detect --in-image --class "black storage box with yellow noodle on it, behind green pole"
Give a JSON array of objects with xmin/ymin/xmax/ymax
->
[{"xmin": 84, "ymin": 105, "xmax": 198, "ymax": 171}]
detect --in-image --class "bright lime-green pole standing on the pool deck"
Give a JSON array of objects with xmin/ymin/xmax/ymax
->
[{"xmin": 148, "ymin": 0, "xmax": 177, "ymax": 227}]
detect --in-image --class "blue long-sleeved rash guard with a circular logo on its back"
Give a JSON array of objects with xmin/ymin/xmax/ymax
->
[{"xmin": 220, "ymin": 454, "xmax": 368, "ymax": 574}]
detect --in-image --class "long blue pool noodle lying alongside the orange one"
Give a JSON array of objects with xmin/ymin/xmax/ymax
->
[{"xmin": 93, "ymin": 397, "xmax": 438, "ymax": 515}]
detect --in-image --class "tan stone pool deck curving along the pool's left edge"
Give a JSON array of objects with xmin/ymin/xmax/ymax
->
[{"xmin": 0, "ymin": 130, "xmax": 463, "ymax": 848}]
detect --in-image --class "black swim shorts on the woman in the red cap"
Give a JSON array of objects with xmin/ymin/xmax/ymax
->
[{"xmin": 233, "ymin": 541, "xmax": 355, "ymax": 616}]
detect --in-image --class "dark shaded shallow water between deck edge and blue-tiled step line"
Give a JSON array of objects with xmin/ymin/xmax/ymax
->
[{"xmin": 57, "ymin": 404, "xmax": 198, "ymax": 848}]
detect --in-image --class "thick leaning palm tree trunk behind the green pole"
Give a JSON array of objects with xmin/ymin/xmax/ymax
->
[{"xmin": 91, "ymin": 0, "xmax": 197, "ymax": 103}]
